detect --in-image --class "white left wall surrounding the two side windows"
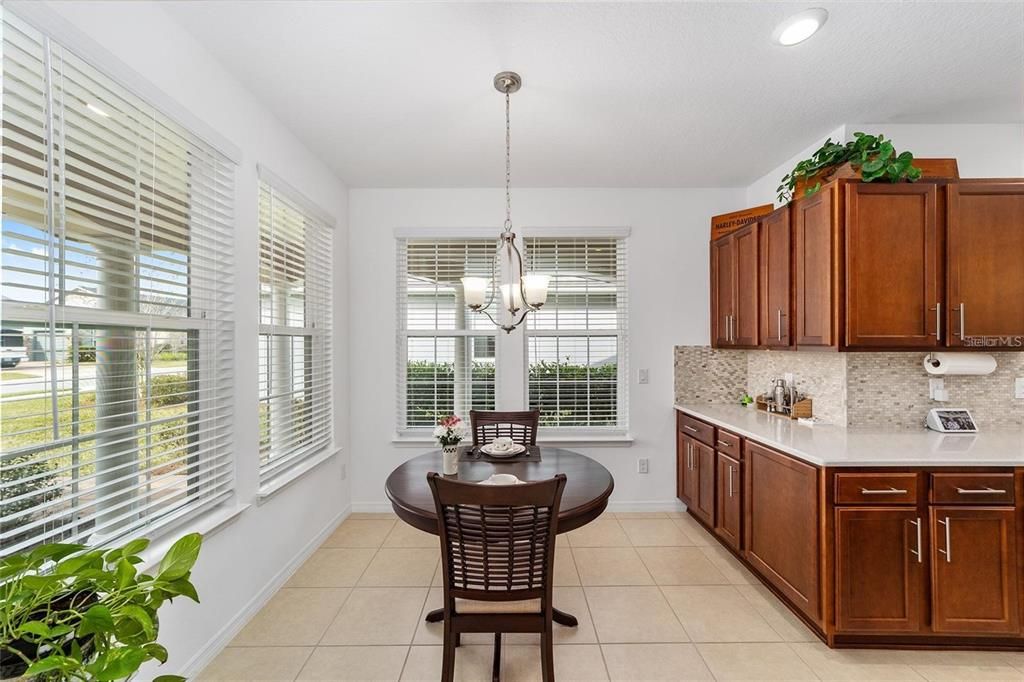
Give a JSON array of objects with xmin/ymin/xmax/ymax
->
[{"xmin": 32, "ymin": 2, "xmax": 349, "ymax": 678}]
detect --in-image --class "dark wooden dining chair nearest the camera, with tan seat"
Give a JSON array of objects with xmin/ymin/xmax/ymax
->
[{"xmin": 427, "ymin": 472, "xmax": 565, "ymax": 682}]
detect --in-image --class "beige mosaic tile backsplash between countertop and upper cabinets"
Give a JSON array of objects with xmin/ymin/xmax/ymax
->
[{"xmin": 675, "ymin": 346, "xmax": 1024, "ymax": 429}]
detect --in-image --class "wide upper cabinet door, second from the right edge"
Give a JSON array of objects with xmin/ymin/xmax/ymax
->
[{"xmin": 846, "ymin": 182, "xmax": 943, "ymax": 348}]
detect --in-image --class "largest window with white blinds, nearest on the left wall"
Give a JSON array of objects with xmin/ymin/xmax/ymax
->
[{"xmin": 0, "ymin": 11, "xmax": 233, "ymax": 554}]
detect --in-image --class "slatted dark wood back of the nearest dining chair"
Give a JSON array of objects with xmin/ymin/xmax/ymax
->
[{"xmin": 427, "ymin": 473, "xmax": 565, "ymax": 601}]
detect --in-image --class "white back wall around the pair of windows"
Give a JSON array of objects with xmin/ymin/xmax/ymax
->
[{"xmin": 349, "ymin": 188, "xmax": 743, "ymax": 511}]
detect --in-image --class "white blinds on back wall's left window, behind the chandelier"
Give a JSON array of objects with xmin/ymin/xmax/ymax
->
[{"xmin": 396, "ymin": 239, "xmax": 497, "ymax": 430}]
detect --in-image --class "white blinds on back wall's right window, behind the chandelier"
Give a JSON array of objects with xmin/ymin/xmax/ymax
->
[{"xmin": 524, "ymin": 238, "xmax": 628, "ymax": 429}]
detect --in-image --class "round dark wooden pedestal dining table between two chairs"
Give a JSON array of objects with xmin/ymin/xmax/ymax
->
[{"xmin": 384, "ymin": 447, "xmax": 615, "ymax": 627}]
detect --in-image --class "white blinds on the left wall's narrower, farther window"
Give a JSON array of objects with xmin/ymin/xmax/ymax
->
[{"xmin": 259, "ymin": 178, "xmax": 334, "ymax": 482}]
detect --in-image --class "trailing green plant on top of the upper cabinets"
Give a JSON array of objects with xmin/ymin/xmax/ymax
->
[{"xmin": 775, "ymin": 132, "xmax": 921, "ymax": 204}]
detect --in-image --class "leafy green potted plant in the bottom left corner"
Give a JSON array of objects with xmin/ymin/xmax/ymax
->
[{"xmin": 0, "ymin": 534, "xmax": 203, "ymax": 682}]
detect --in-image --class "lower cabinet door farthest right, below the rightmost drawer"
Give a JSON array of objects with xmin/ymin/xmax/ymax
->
[{"xmin": 931, "ymin": 507, "xmax": 1020, "ymax": 635}]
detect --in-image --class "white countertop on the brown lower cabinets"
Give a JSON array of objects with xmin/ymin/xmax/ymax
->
[{"xmin": 676, "ymin": 404, "xmax": 1024, "ymax": 467}]
